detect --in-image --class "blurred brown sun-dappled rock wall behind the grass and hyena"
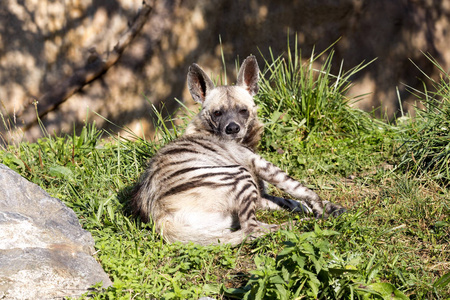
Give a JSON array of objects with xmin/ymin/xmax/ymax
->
[{"xmin": 0, "ymin": 0, "xmax": 450, "ymax": 141}]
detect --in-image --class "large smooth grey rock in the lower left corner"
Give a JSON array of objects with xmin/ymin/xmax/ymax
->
[{"xmin": 0, "ymin": 164, "xmax": 112, "ymax": 299}]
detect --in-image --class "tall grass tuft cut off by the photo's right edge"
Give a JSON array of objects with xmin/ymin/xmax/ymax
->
[{"xmin": 399, "ymin": 54, "xmax": 450, "ymax": 184}]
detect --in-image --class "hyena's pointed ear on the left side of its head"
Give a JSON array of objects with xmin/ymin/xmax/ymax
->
[{"xmin": 188, "ymin": 64, "xmax": 214, "ymax": 103}]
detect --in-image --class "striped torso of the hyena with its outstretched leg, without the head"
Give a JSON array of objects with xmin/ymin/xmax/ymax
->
[{"xmin": 132, "ymin": 136, "xmax": 323, "ymax": 245}]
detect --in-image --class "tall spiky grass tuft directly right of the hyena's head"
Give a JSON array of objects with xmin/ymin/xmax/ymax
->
[{"xmin": 257, "ymin": 39, "xmax": 374, "ymax": 145}]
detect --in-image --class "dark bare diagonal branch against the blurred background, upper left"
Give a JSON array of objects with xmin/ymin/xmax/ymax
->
[{"xmin": 19, "ymin": 0, "xmax": 153, "ymax": 131}]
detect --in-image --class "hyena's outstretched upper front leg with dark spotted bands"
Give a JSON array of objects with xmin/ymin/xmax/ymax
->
[{"xmin": 251, "ymin": 154, "xmax": 345, "ymax": 218}]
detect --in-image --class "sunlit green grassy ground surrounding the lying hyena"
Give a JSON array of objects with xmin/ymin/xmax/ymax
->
[{"xmin": 0, "ymin": 51, "xmax": 450, "ymax": 299}]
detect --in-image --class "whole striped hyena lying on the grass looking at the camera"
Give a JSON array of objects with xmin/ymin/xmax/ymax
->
[{"xmin": 132, "ymin": 56, "xmax": 345, "ymax": 245}]
